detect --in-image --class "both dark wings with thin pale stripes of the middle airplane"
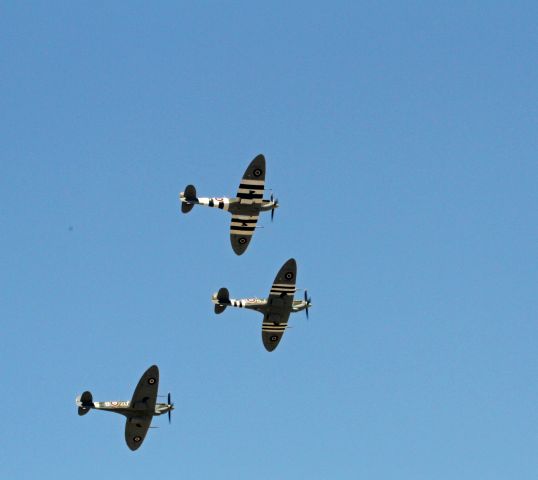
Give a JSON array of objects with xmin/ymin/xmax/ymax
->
[{"xmin": 262, "ymin": 258, "xmax": 297, "ymax": 352}]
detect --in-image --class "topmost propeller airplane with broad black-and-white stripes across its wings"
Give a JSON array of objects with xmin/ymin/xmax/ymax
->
[{"xmin": 179, "ymin": 154, "xmax": 278, "ymax": 255}]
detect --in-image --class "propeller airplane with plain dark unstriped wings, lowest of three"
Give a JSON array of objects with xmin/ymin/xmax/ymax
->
[{"xmin": 76, "ymin": 365, "xmax": 174, "ymax": 450}]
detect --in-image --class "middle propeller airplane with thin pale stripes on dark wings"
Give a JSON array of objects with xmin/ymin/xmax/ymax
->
[{"xmin": 211, "ymin": 258, "xmax": 312, "ymax": 352}]
